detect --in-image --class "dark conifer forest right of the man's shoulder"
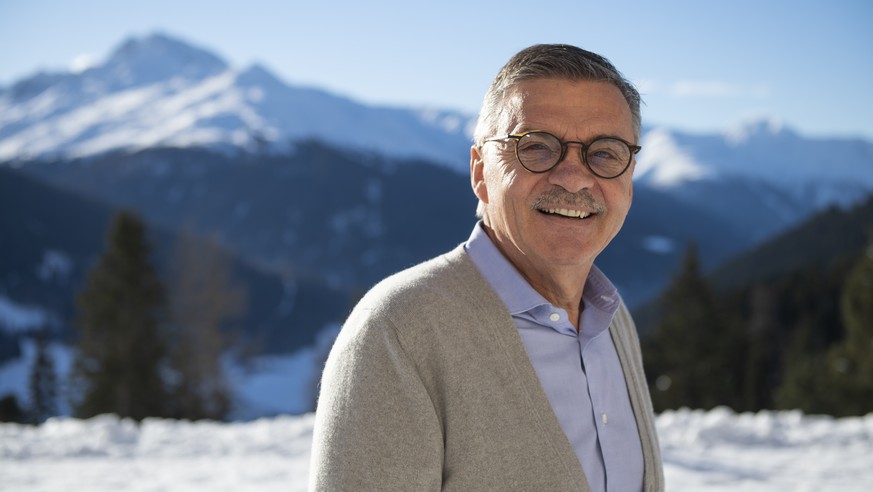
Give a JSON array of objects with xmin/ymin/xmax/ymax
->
[{"xmin": 643, "ymin": 231, "xmax": 873, "ymax": 416}]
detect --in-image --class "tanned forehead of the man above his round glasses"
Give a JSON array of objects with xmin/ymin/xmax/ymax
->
[{"xmin": 500, "ymin": 79, "xmax": 634, "ymax": 141}]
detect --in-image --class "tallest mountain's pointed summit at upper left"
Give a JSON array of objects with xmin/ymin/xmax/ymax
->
[{"xmin": 100, "ymin": 33, "xmax": 228, "ymax": 85}]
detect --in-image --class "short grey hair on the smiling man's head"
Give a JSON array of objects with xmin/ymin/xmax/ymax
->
[{"xmin": 473, "ymin": 44, "xmax": 641, "ymax": 145}]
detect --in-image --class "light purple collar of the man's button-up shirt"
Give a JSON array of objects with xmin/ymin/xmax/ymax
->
[{"xmin": 465, "ymin": 221, "xmax": 621, "ymax": 316}]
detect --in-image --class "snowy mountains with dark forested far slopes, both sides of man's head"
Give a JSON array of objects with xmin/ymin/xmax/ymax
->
[{"xmin": 0, "ymin": 34, "xmax": 873, "ymax": 294}]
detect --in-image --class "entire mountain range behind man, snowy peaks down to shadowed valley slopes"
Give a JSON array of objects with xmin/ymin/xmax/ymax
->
[{"xmin": 0, "ymin": 31, "xmax": 873, "ymax": 430}]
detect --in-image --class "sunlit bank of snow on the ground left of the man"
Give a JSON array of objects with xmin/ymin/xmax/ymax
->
[{"xmin": 0, "ymin": 415, "xmax": 312, "ymax": 492}]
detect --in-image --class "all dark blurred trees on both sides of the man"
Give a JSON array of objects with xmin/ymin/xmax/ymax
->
[{"xmin": 0, "ymin": 211, "xmax": 873, "ymax": 423}]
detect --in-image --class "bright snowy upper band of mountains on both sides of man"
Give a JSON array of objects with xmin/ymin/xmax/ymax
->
[{"xmin": 0, "ymin": 33, "xmax": 873, "ymax": 192}]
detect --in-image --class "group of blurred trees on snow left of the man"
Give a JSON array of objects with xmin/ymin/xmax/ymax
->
[{"xmin": 7, "ymin": 211, "xmax": 246, "ymax": 423}]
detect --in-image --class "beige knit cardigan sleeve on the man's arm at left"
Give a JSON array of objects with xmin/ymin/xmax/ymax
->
[{"xmin": 309, "ymin": 309, "xmax": 444, "ymax": 491}]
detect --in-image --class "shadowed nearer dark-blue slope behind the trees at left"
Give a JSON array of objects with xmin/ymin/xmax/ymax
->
[{"xmin": 0, "ymin": 167, "xmax": 352, "ymax": 363}]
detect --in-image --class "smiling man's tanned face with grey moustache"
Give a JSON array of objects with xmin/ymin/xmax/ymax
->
[{"xmin": 470, "ymin": 79, "xmax": 635, "ymax": 280}]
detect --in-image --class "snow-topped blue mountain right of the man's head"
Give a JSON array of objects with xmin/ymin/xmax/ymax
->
[{"xmin": 634, "ymin": 119, "xmax": 873, "ymax": 241}]
